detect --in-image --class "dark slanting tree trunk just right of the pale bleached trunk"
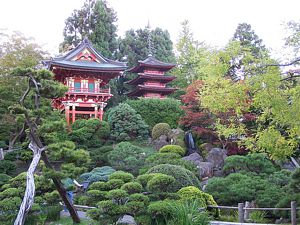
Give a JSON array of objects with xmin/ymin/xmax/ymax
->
[{"xmin": 42, "ymin": 152, "xmax": 80, "ymax": 223}]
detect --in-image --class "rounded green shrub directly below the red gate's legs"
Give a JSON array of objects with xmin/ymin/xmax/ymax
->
[{"xmin": 70, "ymin": 119, "xmax": 110, "ymax": 147}]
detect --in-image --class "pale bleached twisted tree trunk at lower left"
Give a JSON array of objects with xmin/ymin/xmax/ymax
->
[{"xmin": 14, "ymin": 143, "xmax": 44, "ymax": 225}]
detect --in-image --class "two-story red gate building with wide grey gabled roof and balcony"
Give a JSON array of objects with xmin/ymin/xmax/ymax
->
[{"xmin": 47, "ymin": 39, "xmax": 126, "ymax": 125}]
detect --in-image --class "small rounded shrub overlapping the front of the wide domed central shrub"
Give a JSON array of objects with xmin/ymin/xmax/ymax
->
[{"xmin": 147, "ymin": 174, "xmax": 175, "ymax": 193}]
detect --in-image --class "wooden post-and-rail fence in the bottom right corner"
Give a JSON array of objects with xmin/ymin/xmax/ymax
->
[{"xmin": 208, "ymin": 201, "xmax": 300, "ymax": 225}]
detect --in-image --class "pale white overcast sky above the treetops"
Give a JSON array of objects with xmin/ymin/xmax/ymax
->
[{"xmin": 0, "ymin": 0, "xmax": 300, "ymax": 57}]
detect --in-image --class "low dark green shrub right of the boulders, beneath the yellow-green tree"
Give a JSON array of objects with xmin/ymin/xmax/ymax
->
[{"xmin": 223, "ymin": 153, "xmax": 276, "ymax": 174}]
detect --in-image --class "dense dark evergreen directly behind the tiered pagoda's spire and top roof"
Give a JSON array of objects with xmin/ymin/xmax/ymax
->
[{"xmin": 119, "ymin": 27, "xmax": 175, "ymax": 67}]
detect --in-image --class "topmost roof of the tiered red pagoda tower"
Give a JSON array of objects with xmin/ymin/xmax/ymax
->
[{"xmin": 127, "ymin": 55, "xmax": 176, "ymax": 73}]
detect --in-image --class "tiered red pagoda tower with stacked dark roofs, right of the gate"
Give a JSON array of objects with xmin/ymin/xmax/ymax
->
[{"xmin": 126, "ymin": 55, "xmax": 176, "ymax": 98}]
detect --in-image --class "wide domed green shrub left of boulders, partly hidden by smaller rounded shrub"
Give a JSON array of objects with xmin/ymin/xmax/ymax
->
[{"xmin": 147, "ymin": 164, "xmax": 200, "ymax": 192}]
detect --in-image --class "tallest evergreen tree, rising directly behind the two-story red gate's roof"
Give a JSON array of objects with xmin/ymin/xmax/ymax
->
[{"xmin": 60, "ymin": 0, "xmax": 117, "ymax": 58}]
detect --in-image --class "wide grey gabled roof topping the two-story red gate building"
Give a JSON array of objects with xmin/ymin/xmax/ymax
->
[{"xmin": 46, "ymin": 38, "xmax": 127, "ymax": 71}]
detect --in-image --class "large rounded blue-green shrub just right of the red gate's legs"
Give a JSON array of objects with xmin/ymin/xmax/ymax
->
[{"xmin": 107, "ymin": 103, "xmax": 149, "ymax": 141}]
